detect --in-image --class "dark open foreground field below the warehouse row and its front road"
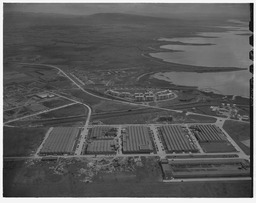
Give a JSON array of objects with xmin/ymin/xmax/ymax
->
[{"xmin": 3, "ymin": 157, "xmax": 252, "ymax": 197}]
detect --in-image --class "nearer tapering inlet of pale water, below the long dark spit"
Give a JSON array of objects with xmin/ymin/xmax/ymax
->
[{"xmin": 153, "ymin": 70, "xmax": 251, "ymax": 97}]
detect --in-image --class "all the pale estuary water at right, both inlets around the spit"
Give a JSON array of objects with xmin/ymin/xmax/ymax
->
[{"xmin": 150, "ymin": 24, "xmax": 252, "ymax": 97}]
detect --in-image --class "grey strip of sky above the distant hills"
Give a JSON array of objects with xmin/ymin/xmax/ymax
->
[{"xmin": 4, "ymin": 3, "xmax": 249, "ymax": 18}]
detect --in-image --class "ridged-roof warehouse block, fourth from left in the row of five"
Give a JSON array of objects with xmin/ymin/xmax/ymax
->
[{"xmin": 158, "ymin": 125, "xmax": 198, "ymax": 153}]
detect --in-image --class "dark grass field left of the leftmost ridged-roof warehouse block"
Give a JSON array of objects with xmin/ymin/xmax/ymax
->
[{"xmin": 3, "ymin": 127, "xmax": 47, "ymax": 157}]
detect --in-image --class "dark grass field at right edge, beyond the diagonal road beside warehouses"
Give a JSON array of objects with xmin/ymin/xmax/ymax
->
[{"xmin": 223, "ymin": 120, "xmax": 251, "ymax": 155}]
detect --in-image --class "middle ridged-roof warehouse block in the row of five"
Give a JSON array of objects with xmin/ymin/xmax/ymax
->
[{"xmin": 123, "ymin": 126, "xmax": 153, "ymax": 153}]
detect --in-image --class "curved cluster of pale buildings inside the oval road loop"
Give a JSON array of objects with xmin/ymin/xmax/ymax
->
[{"xmin": 106, "ymin": 89, "xmax": 174, "ymax": 102}]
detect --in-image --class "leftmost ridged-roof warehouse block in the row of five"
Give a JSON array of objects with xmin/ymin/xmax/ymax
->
[{"xmin": 40, "ymin": 127, "xmax": 80, "ymax": 155}]
